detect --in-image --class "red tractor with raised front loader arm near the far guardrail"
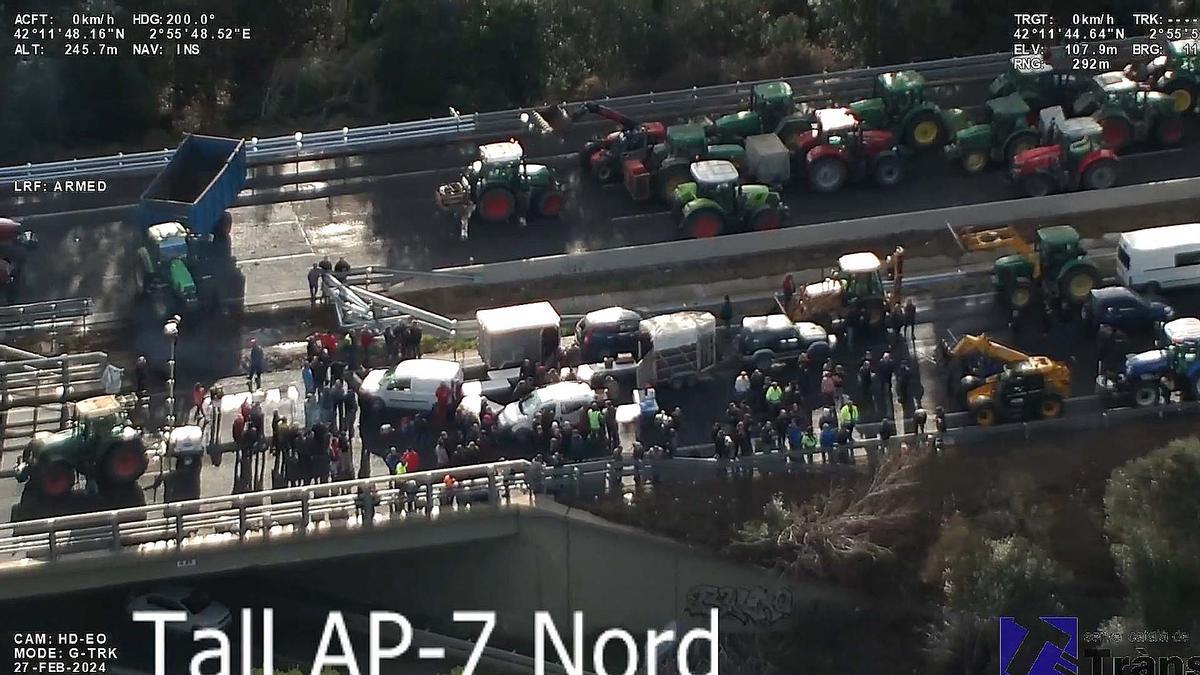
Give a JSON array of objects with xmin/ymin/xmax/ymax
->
[{"xmin": 532, "ymin": 102, "xmax": 667, "ymax": 183}]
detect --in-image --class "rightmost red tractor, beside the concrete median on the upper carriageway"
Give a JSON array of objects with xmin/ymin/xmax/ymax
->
[{"xmin": 1009, "ymin": 106, "xmax": 1120, "ymax": 197}]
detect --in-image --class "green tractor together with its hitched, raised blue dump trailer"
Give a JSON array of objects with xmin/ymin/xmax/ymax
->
[{"xmin": 136, "ymin": 135, "xmax": 246, "ymax": 316}]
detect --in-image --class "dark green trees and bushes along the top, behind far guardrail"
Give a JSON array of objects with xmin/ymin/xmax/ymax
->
[{"xmin": 0, "ymin": 0, "xmax": 1182, "ymax": 163}]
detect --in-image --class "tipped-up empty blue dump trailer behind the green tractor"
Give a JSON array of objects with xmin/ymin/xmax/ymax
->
[{"xmin": 138, "ymin": 133, "xmax": 246, "ymax": 237}]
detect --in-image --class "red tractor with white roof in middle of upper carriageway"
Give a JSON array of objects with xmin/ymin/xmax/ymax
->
[{"xmin": 796, "ymin": 108, "xmax": 904, "ymax": 192}]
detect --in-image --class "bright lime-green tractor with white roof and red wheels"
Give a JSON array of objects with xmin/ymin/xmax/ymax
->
[{"xmin": 674, "ymin": 160, "xmax": 787, "ymax": 239}]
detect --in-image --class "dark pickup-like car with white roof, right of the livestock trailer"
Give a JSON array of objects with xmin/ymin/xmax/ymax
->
[{"xmin": 738, "ymin": 313, "xmax": 838, "ymax": 371}]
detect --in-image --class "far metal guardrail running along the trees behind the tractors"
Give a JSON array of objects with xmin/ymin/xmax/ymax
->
[{"xmin": 0, "ymin": 40, "xmax": 1134, "ymax": 181}]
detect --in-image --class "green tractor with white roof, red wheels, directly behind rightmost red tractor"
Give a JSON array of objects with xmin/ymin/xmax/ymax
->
[{"xmin": 1081, "ymin": 72, "xmax": 1183, "ymax": 151}]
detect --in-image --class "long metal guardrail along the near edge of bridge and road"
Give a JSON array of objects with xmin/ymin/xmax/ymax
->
[{"xmin": 0, "ymin": 396, "xmax": 1180, "ymax": 562}]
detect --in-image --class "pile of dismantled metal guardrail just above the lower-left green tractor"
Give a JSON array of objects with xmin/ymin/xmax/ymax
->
[{"xmin": 0, "ymin": 352, "xmax": 108, "ymax": 411}]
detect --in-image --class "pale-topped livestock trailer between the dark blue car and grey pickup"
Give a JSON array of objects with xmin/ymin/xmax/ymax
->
[{"xmin": 637, "ymin": 312, "xmax": 716, "ymax": 387}]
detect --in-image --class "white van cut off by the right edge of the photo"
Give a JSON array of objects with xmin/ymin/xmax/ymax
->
[{"xmin": 1117, "ymin": 222, "xmax": 1200, "ymax": 292}]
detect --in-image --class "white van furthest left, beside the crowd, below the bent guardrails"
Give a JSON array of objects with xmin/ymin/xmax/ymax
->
[{"xmin": 360, "ymin": 359, "xmax": 463, "ymax": 412}]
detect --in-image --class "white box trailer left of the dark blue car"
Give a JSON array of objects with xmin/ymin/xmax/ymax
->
[{"xmin": 475, "ymin": 301, "xmax": 562, "ymax": 370}]
